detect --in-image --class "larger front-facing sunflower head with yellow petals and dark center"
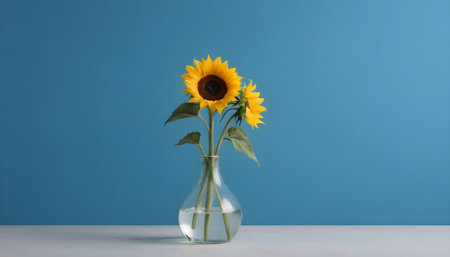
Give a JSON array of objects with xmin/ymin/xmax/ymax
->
[{"xmin": 182, "ymin": 55, "xmax": 242, "ymax": 114}]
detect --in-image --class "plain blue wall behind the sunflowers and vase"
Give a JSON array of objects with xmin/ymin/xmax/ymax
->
[{"xmin": 0, "ymin": 0, "xmax": 450, "ymax": 224}]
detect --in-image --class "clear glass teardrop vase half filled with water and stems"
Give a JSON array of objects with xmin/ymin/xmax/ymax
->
[{"xmin": 179, "ymin": 156, "xmax": 242, "ymax": 243}]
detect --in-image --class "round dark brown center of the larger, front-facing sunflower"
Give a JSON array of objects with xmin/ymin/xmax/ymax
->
[{"xmin": 198, "ymin": 75, "xmax": 228, "ymax": 101}]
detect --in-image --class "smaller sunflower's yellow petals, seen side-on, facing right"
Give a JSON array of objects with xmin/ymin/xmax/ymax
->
[{"xmin": 242, "ymin": 80, "xmax": 266, "ymax": 128}]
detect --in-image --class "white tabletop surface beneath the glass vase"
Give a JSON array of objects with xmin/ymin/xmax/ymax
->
[{"xmin": 0, "ymin": 226, "xmax": 450, "ymax": 257}]
